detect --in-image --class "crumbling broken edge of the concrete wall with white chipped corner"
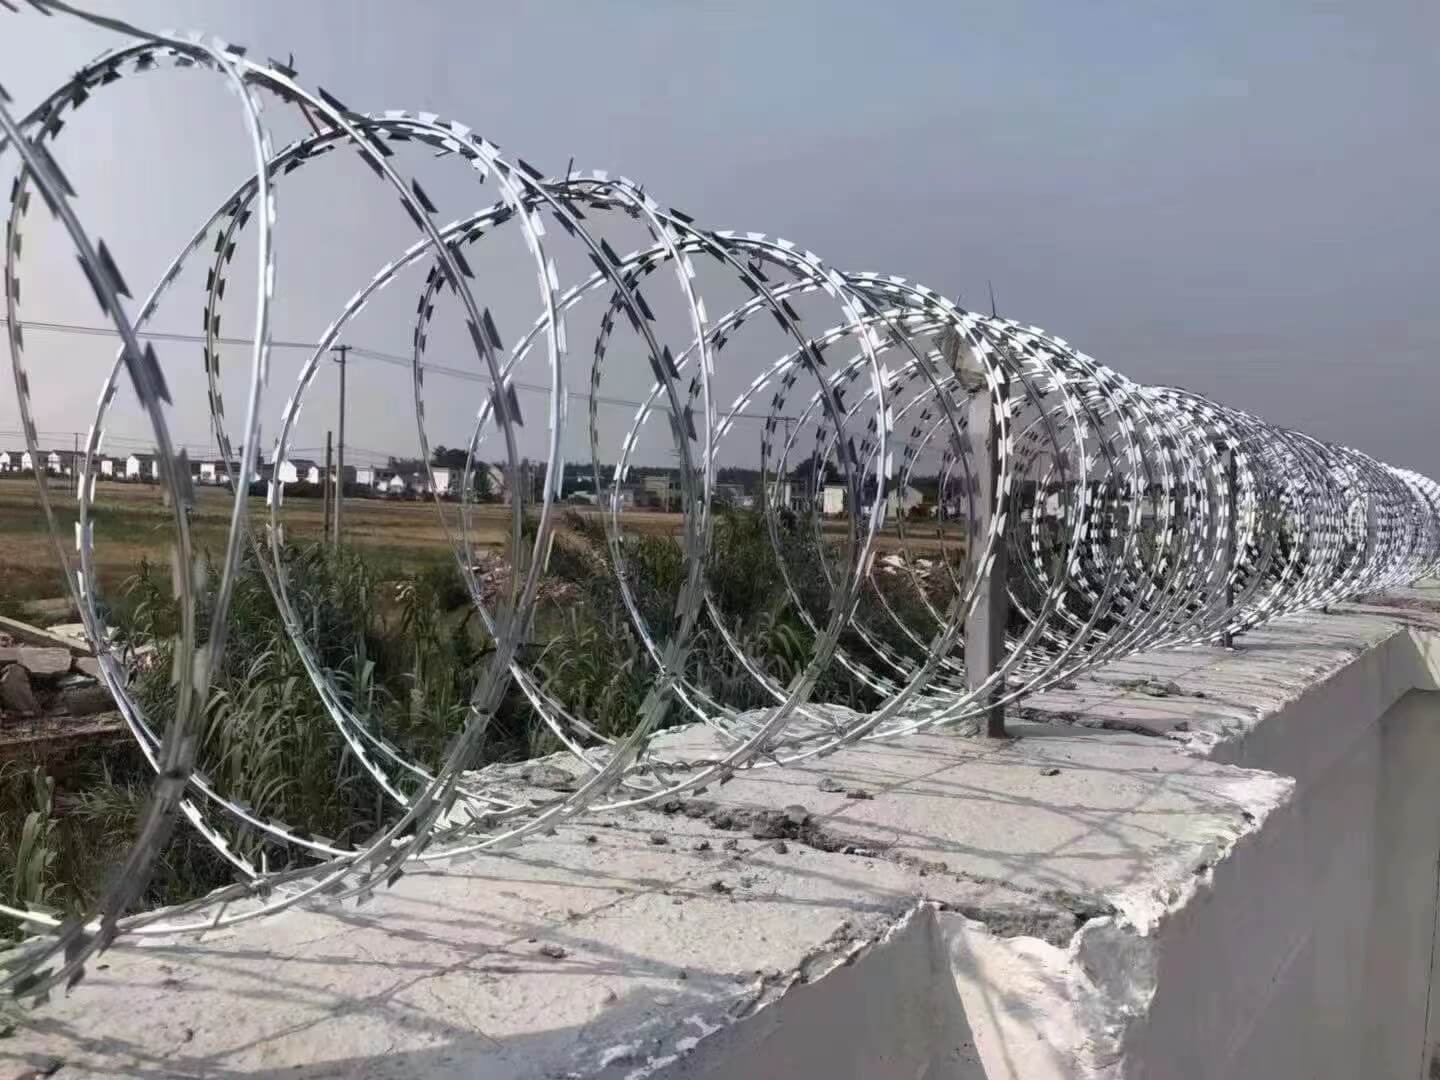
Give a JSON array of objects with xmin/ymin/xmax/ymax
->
[{"xmin": 659, "ymin": 625, "xmax": 1440, "ymax": 1080}]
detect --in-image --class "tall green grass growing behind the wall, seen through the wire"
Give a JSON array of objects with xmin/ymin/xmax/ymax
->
[{"xmin": 0, "ymin": 514, "xmax": 915, "ymax": 933}]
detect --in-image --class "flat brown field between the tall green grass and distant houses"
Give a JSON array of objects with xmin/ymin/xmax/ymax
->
[{"xmin": 0, "ymin": 477, "xmax": 967, "ymax": 605}]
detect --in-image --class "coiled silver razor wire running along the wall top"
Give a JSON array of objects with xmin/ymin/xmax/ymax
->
[{"xmin": 0, "ymin": 0, "xmax": 1440, "ymax": 995}]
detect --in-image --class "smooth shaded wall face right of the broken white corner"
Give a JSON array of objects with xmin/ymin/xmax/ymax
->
[{"xmin": 1123, "ymin": 691, "xmax": 1440, "ymax": 1080}]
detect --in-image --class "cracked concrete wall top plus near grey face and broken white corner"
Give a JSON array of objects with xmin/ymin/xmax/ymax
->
[{"xmin": 0, "ymin": 596, "xmax": 1433, "ymax": 1080}]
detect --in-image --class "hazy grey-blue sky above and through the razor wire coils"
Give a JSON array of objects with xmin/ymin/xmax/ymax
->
[{"xmin": 0, "ymin": 0, "xmax": 1440, "ymax": 475}]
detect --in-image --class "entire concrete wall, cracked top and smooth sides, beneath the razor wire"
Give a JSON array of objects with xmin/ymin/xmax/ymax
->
[{"xmin": 8, "ymin": 604, "xmax": 1440, "ymax": 1080}]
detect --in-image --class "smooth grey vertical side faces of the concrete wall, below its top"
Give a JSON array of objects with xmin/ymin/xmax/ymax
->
[{"xmin": 674, "ymin": 673, "xmax": 1440, "ymax": 1080}]
